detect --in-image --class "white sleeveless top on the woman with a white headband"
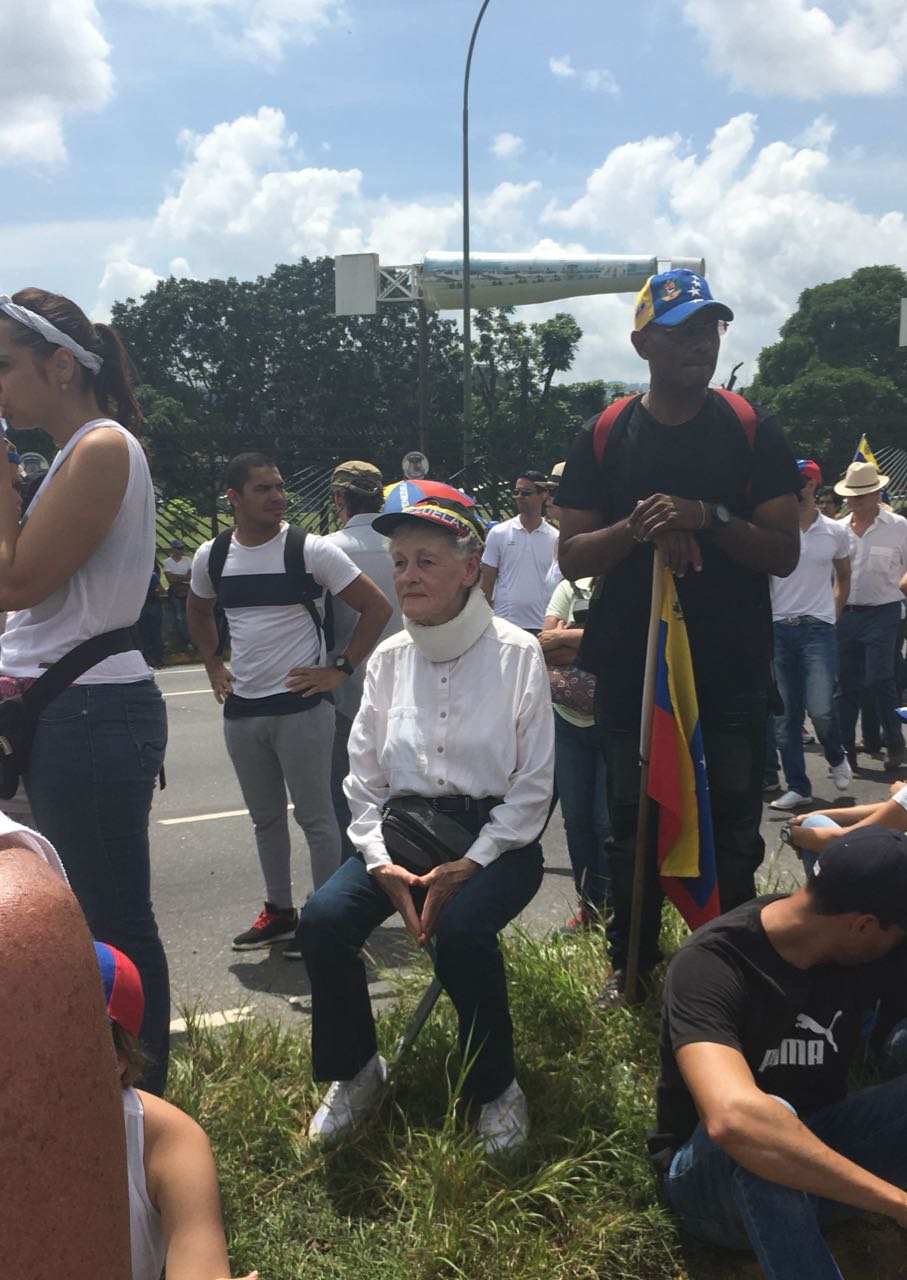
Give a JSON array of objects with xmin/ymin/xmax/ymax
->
[{"xmin": 0, "ymin": 417, "xmax": 155, "ymax": 685}]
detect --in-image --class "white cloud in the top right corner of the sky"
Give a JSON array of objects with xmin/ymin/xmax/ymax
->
[{"xmin": 683, "ymin": 0, "xmax": 907, "ymax": 99}]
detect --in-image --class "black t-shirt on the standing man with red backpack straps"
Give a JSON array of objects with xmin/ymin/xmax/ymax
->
[{"xmin": 558, "ymin": 392, "xmax": 800, "ymax": 730}]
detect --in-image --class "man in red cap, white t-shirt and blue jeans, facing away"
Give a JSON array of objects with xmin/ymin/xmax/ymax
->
[{"xmin": 770, "ymin": 458, "xmax": 853, "ymax": 809}]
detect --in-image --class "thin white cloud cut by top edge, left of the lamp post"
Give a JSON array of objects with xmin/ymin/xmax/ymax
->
[{"xmin": 132, "ymin": 0, "xmax": 348, "ymax": 61}]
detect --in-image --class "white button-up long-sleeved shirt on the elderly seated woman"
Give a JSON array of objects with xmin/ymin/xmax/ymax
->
[{"xmin": 343, "ymin": 618, "xmax": 554, "ymax": 869}]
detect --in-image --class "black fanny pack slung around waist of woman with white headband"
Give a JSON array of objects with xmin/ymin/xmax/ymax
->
[{"xmin": 0, "ymin": 627, "xmax": 138, "ymax": 800}]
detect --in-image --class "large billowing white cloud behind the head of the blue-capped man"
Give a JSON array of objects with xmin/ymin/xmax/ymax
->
[{"xmin": 545, "ymin": 114, "xmax": 907, "ymax": 379}]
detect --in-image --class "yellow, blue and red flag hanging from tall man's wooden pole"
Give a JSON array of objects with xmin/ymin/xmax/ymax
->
[{"xmin": 647, "ymin": 570, "xmax": 720, "ymax": 929}]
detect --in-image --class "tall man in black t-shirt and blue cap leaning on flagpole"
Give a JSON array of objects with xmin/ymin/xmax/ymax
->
[{"xmin": 558, "ymin": 270, "xmax": 800, "ymax": 1007}]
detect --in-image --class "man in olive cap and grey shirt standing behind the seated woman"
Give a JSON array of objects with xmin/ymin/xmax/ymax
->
[{"xmin": 327, "ymin": 461, "xmax": 403, "ymax": 861}]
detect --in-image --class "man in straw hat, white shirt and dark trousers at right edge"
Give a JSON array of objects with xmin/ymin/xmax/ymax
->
[{"xmin": 834, "ymin": 462, "xmax": 907, "ymax": 769}]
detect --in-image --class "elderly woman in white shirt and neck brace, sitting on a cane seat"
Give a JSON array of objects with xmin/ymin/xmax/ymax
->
[{"xmin": 297, "ymin": 499, "xmax": 554, "ymax": 1153}]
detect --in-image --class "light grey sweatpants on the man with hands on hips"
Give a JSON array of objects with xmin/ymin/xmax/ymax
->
[{"xmin": 224, "ymin": 701, "xmax": 340, "ymax": 908}]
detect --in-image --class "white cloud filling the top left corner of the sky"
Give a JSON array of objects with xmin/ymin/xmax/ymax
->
[{"xmin": 0, "ymin": 0, "xmax": 114, "ymax": 168}]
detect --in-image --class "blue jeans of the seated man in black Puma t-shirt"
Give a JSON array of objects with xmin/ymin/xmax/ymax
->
[{"xmin": 664, "ymin": 1075, "xmax": 907, "ymax": 1280}]
